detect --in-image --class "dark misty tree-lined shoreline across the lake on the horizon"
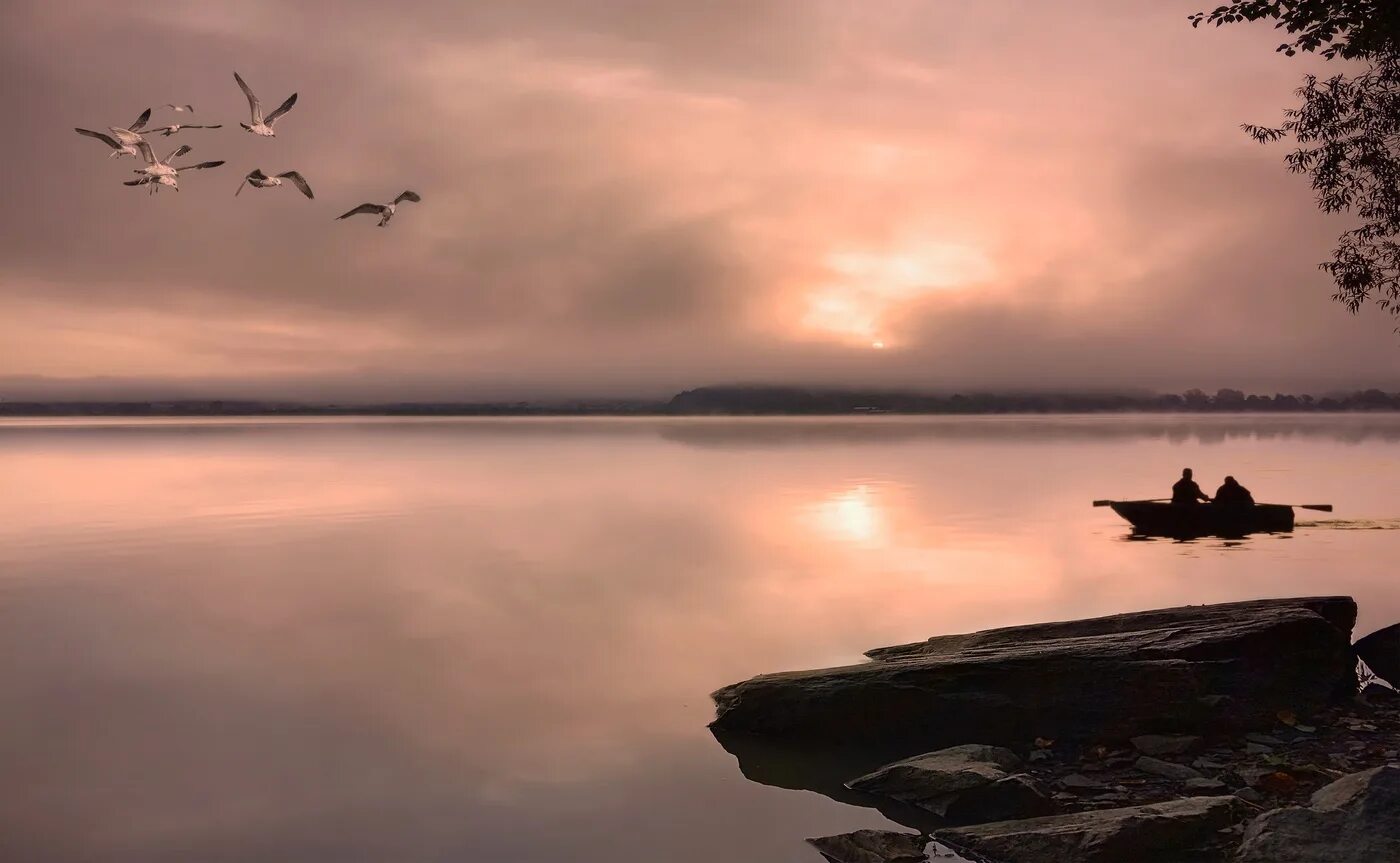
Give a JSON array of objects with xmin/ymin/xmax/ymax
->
[{"xmin": 0, "ymin": 387, "xmax": 1400, "ymax": 417}]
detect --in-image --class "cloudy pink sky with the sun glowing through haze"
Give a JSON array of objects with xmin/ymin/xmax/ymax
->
[{"xmin": 0, "ymin": 0, "xmax": 1400, "ymax": 401}]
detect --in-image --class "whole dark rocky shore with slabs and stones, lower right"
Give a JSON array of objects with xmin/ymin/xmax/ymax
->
[{"xmin": 711, "ymin": 597, "xmax": 1400, "ymax": 863}]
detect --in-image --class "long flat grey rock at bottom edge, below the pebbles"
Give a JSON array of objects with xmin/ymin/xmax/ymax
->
[{"xmin": 937, "ymin": 797, "xmax": 1247, "ymax": 863}]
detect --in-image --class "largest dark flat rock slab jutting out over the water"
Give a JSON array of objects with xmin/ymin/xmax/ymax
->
[{"xmin": 713, "ymin": 597, "xmax": 1355, "ymax": 754}]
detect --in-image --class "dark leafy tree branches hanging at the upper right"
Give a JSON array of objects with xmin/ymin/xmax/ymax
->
[{"xmin": 1191, "ymin": 0, "xmax": 1400, "ymax": 317}]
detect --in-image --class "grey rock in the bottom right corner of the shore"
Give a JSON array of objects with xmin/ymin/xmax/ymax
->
[{"xmin": 1239, "ymin": 765, "xmax": 1400, "ymax": 863}]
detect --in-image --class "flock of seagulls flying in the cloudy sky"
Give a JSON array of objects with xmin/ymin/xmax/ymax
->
[{"xmin": 74, "ymin": 71, "xmax": 423, "ymax": 228}]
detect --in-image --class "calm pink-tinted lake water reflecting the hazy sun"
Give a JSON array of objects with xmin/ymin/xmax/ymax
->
[{"xmin": 0, "ymin": 416, "xmax": 1400, "ymax": 863}]
